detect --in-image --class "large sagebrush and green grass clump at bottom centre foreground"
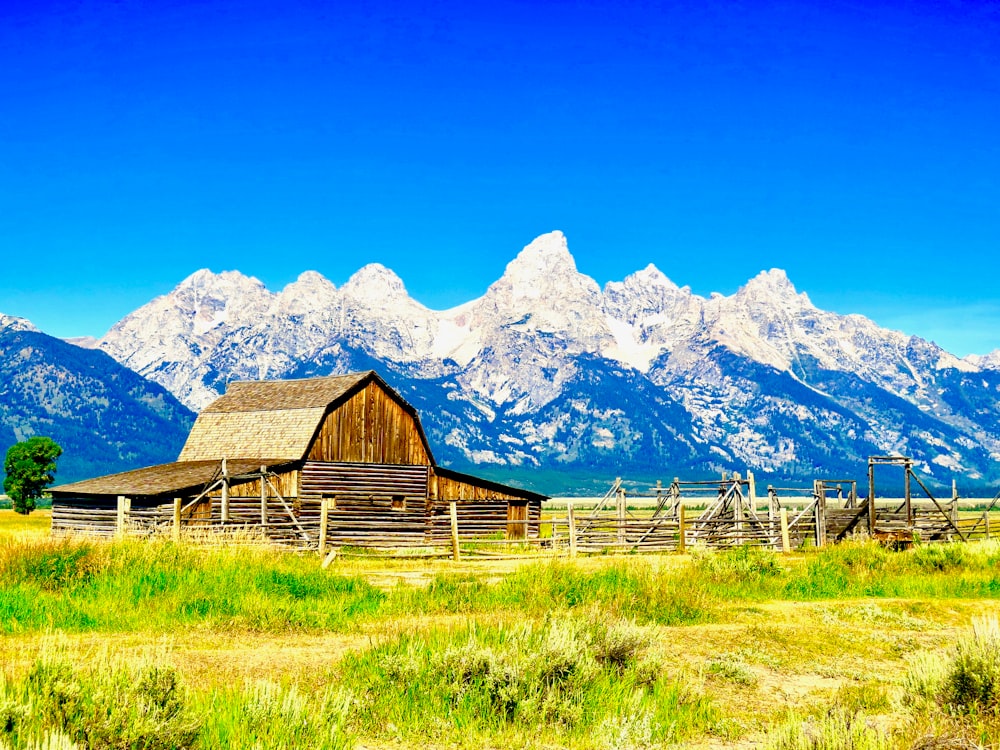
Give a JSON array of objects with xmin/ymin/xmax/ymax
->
[{"xmin": 341, "ymin": 618, "xmax": 719, "ymax": 747}]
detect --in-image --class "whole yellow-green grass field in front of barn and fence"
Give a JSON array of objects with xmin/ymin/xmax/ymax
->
[{"xmin": 0, "ymin": 511, "xmax": 1000, "ymax": 750}]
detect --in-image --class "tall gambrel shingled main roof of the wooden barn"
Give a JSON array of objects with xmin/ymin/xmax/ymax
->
[{"xmin": 178, "ymin": 371, "xmax": 378, "ymax": 461}]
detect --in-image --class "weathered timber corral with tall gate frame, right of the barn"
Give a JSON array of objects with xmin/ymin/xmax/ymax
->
[{"xmin": 568, "ymin": 456, "xmax": 1000, "ymax": 554}]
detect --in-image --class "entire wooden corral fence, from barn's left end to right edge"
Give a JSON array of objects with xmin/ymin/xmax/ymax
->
[{"xmin": 53, "ymin": 456, "xmax": 1000, "ymax": 559}]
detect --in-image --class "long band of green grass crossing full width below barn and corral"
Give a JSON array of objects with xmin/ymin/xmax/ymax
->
[{"xmin": 0, "ymin": 537, "xmax": 1000, "ymax": 634}]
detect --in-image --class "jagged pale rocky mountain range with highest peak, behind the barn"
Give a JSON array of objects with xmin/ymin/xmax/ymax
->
[{"xmin": 98, "ymin": 232, "xmax": 1000, "ymax": 491}]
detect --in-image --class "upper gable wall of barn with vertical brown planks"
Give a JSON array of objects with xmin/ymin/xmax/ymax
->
[{"xmin": 307, "ymin": 382, "xmax": 431, "ymax": 466}]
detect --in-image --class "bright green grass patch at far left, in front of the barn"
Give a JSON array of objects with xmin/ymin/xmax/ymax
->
[{"xmin": 0, "ymin": 539, "xmax": 385, "ymax": 633}]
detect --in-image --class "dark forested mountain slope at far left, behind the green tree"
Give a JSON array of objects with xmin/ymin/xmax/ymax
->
[{"xmin": 0, "ymin": 315, "xmax": 194, "ymax": 483}]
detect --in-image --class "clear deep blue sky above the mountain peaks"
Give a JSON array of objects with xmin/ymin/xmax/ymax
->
[{"xmin": 0, "ymin": 0, "xmax": 1000, "ymax": 355}]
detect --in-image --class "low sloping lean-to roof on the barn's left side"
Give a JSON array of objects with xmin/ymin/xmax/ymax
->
[{"xmin": 52, "ymin": 458, "xmax": 287, "ymax": 497}]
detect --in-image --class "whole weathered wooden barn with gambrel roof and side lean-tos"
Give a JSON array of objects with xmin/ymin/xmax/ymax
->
[{"xmin": 52, "ymin": 371, "xmax": 545, "ymax": 547}]
